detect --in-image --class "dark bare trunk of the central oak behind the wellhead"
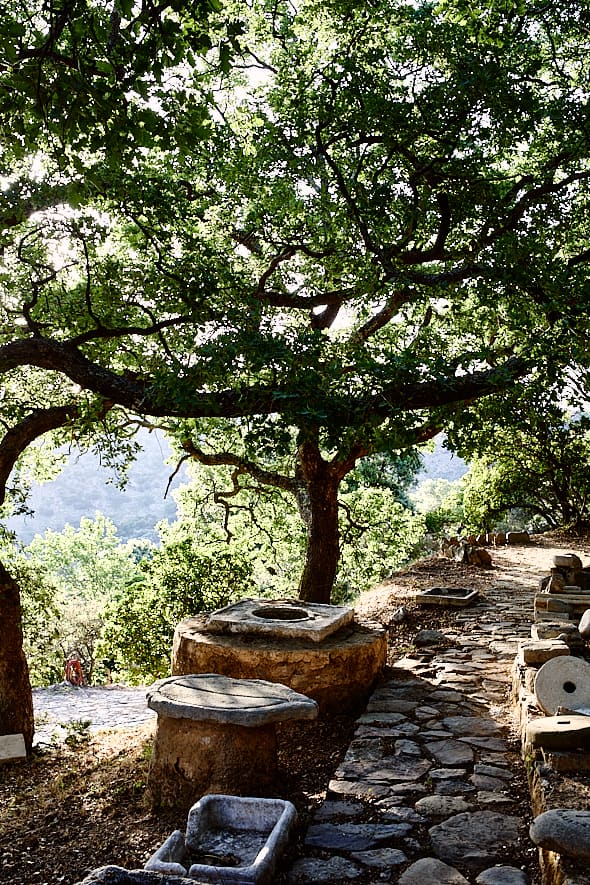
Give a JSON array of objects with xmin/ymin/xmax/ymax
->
[{"xmin": 298, "ymin": 443, "xmax": 341, "ymax": 604}]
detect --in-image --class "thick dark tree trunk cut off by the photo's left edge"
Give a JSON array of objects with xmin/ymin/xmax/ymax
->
[{"xmin": 0, "ymin": 562, "xmax": 35, "ymax": 752}]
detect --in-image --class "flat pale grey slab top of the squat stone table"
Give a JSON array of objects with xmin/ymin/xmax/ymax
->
[{"xmin": 147, "ymin": 673, "xmax": 318, "ymax": 727}]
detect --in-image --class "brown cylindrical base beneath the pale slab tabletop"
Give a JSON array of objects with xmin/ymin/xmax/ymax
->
[{"xmin": 148, "ymin": 716, "xmax": 277, "ymax": 808}]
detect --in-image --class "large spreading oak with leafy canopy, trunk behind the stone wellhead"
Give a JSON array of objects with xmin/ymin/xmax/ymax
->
[{"xmin": 0, "ymin": 0, "xmax": 590, "ymax": 744}]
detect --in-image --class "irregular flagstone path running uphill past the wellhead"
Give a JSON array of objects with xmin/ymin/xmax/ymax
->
[{"xmin": 288, "ymin": 574, "xmax": 538, "ymax": 885}]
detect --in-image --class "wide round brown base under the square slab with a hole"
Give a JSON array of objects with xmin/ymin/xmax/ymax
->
[{"xmin": 172, "ymin": 616, "xmax": 387, "ymax": 713}]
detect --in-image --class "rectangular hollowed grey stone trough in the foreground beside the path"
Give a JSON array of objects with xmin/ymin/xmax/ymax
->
[{"xmin": 145, "ymin": 795, "xmax": 297, "ymax": 885}]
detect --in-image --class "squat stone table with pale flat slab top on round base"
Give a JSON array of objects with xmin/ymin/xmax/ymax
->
[{"xmin": 147, "ymin": 673, "xmax": 318, "ymax": 807}]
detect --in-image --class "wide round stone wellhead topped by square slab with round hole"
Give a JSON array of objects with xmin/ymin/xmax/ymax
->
[{"xmin": 172, "ymin": 599, "xmax": 387, "ymax": 713}]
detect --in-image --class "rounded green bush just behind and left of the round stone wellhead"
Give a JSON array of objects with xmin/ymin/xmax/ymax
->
[{"xmin": 101, "ymin": 539, "xmax": 252, "ymax": 682}]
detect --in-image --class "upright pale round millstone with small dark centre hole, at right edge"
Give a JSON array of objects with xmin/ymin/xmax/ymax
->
[{"xmin": 535, "ymin": 655, "xmax": 590, "ymax": 716}]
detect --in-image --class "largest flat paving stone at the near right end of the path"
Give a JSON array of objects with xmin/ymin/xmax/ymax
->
[{"xmin": 428, "ymin": 811, "xmax": 519, "ymax": 871}]
